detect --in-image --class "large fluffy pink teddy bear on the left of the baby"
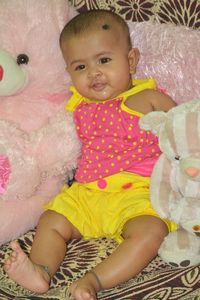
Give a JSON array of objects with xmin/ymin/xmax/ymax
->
[{"xmin": 0, "ymin": 0, "xmax": 80, "ymax": 244}]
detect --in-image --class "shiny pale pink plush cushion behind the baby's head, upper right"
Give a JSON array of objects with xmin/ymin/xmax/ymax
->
[{"xmin": 128, "ymin": 22, "xmax": 200, "ymax": 104}]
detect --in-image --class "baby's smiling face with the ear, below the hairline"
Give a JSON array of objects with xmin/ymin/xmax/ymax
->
[{"xmin": 62, "ymin": 29, "xmax": 136, "ymax": 101}]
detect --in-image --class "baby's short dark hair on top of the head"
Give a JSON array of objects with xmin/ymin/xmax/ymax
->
[{"xmin": 60, "ymin": 9, "xmax": 132, "ymax": 48}]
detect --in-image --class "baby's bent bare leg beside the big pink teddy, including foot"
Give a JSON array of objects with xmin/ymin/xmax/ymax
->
[{"xmin": 4, "ymin": 211, "xmax": 80, "ymax": 293}]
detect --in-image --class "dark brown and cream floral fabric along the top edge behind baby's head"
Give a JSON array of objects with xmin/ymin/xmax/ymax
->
[{"xmin": 70, "ymin": 0, "xmax": 200, "ymax": 29}]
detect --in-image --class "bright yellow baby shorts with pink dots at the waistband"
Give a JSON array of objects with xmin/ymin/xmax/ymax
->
[{"xmin": 44, "ymin": 172, "xmax": 177, "ymax": 243}]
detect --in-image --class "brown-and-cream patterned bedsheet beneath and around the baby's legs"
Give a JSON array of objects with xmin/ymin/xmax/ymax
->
[{"xmin": 0, "ymin": 231, "xmax": 200, "ymax": 300}]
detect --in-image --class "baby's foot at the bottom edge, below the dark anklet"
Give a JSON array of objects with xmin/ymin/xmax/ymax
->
[{"xmin": 70, "ymin": 272, "xmax": 99, "ymax": 300}]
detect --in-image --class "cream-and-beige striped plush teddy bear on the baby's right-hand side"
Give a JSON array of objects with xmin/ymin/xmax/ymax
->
[{"xmin": 140, "ymin": 99, "xmax": 200, "ymax": 267}]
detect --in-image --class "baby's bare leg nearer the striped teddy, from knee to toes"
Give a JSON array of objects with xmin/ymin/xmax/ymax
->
[{"xmin": 70, "ymin": 216, "xmax": 168, "ymax": 300}]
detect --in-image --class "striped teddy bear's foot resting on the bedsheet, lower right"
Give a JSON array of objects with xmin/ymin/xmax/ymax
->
[{"xmin": 158, "ymin": 230, "xmax": 200, "ymax": 268}]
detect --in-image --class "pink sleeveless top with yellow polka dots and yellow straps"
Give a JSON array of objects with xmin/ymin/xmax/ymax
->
[{"xmin": 66, "ymin": 79, "xmax": 160, "ymax": 182}]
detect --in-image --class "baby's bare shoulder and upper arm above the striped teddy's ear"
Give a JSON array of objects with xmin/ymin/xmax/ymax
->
[{"xmin": 125, "ymin": 89, "xmax": 176, "ymax": 114}]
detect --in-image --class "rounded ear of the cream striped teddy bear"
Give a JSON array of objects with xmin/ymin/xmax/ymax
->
[{"xmin": 139, "ymin": 111, "xmax": 167, "ymax": 135}]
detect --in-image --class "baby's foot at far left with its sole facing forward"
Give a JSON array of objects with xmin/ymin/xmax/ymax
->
[{"xmin": 4, "ymin": 241, "xmax": 50, "ymax": 293}]
